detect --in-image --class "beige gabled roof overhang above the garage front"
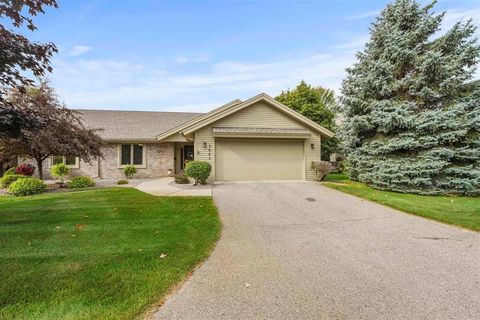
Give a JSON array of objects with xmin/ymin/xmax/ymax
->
[{"xmin": 157, "ymin": 93, "xmax": 333, "ymax": 141}]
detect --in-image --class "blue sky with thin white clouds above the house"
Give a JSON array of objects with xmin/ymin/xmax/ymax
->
[{"xmin": 20, "ymin": 0, "xmax": 480, "ymax": 112}]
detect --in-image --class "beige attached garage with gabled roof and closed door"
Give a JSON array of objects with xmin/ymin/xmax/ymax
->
[{"xmin": 157, "ymin": 93, "xmax": 333, "ymax": 181}]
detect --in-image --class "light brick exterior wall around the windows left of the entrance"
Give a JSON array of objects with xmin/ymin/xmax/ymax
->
[{"xmin": 18, "ymin": 142, "xmax": 175, "ymax": 179}]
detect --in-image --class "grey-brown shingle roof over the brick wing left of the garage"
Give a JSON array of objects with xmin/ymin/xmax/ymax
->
[{"xmin": 76, "ymin": 109, "xmax": 202, "ymax": 141}]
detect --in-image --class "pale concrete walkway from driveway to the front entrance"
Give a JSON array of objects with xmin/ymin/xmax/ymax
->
[{"xmin": 135, "ymin": 177, "xmax": 212, "ymax": 197}]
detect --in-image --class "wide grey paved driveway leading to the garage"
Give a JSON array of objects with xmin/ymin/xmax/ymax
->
[{"xmin": 154, "ymin": 182, "xmax": 480, "ymax": 320}]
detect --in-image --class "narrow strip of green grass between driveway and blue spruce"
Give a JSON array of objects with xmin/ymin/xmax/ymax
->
[{"xmin": 324, "ymin": 174, "xmax": 480, "ymax": 231}]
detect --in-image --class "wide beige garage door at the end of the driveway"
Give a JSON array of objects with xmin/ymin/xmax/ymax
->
[{"xmin": 215, "ymin": 139, "xmax": 305, "ymax": 181}]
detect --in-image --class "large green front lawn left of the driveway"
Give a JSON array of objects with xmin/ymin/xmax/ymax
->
[{"xmin": 0, "ymin": 188, "xmax": 221, "ymax": 319}]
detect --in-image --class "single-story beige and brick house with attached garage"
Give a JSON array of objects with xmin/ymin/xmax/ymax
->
[{"xmin": 35, "ymin": 93, "xmax": 333, "ymax": 181}]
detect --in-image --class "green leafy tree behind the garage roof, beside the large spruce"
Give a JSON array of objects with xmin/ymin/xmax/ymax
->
[{"xmin": 275, "ymin": 81, "xmax": 338, "ymax": 161}]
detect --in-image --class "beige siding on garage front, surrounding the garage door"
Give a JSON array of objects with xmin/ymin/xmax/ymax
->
[{"xmin": 194, "ymin": 102, "xmax": 321, "ymax": 180}]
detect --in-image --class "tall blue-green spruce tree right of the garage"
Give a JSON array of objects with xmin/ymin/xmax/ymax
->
[{"xmin": 342, "ymin": 0, "xmax": 480, "ymax": 195}]
